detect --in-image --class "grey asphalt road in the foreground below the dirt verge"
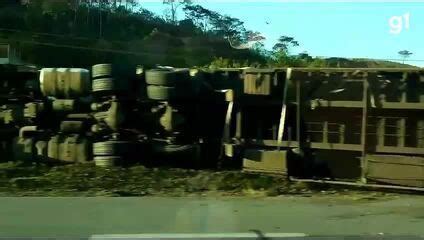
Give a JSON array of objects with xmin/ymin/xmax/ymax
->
[{"xmin": 0, "ymin": 195, "xmax": 424, "ymax": 237}]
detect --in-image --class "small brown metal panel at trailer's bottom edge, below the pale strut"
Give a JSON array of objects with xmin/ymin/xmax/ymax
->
[{"xmin": 243, "ymin": 149, "xmax": 287, "ymax": 175}]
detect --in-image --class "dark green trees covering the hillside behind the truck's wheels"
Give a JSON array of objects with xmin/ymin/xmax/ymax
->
[{"xmin": 0, "ymin": 0, "xmax": 265, "ymax": 67}]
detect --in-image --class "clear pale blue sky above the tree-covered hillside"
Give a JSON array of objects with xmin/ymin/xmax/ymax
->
[{"xmin": 140, "ymin": 0, "xmax": 424, "ymax": 67}]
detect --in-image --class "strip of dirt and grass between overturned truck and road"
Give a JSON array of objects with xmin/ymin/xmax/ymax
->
[{"xmin": 0, "ymin": 162, "xmax": 398, "ymax": 196}]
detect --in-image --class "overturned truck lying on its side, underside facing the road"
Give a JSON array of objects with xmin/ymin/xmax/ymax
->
[{"xmin": 0, "ymin": 64, "xmax": 424, "ymax": 188}]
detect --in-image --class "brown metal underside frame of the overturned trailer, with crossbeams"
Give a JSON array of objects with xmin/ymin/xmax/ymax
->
[{"xmin": 230, "ymin": 68, "xmax": 424, "ymax": 188}]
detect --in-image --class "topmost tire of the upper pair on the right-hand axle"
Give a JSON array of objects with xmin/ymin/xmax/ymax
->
[{"xmin": 146, "ymin": 69, "xmax": 190, "ymax": 86}]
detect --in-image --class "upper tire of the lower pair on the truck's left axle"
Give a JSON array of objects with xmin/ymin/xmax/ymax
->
[{"xmin": 93, "ymin": 141, "xmax": 132, "ymax": 156}]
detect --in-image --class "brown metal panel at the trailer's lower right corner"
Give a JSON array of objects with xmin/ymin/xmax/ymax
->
[{"xmin": 365, "ymin": 154, "xmax": 424, "ymax": 187}]
